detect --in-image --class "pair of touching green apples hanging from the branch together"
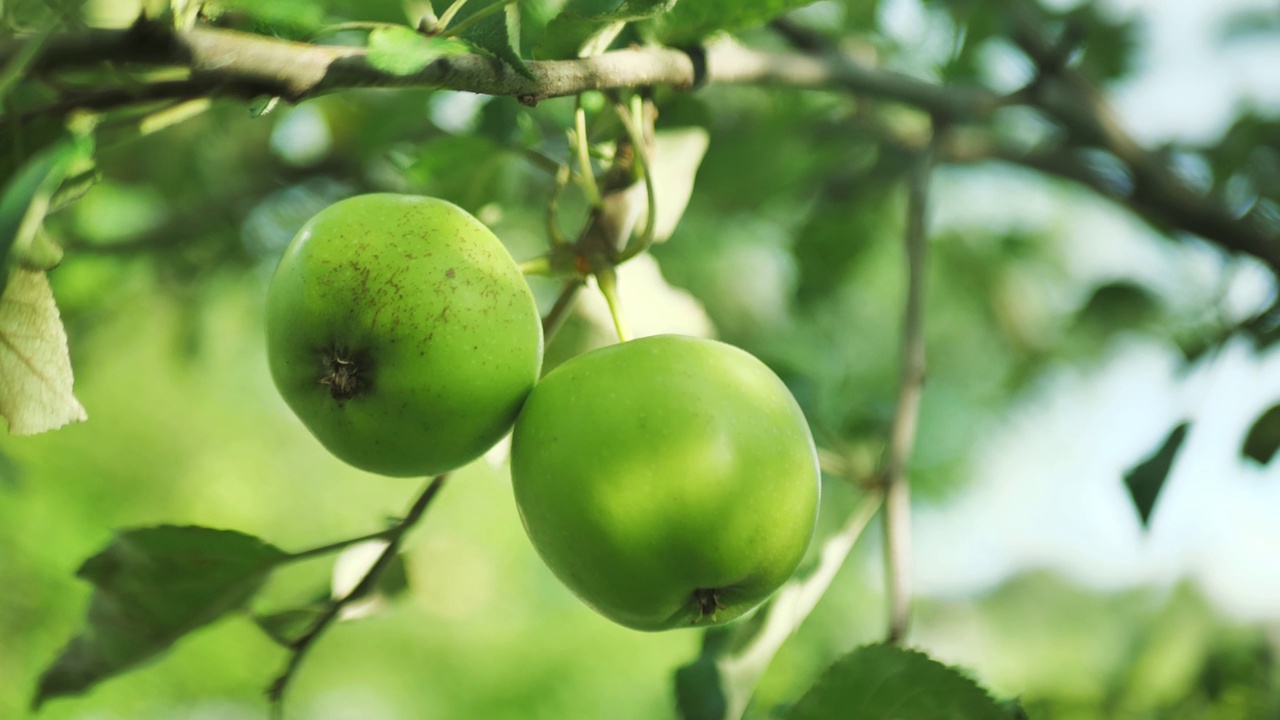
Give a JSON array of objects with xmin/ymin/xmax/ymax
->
[{"xmin": 268, "ymin": 193, "xmax": 819, "ymax": 630}]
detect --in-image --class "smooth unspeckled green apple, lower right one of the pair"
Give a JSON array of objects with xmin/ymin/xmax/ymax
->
[{"xmin": 511, "ymin": 336, "xmax": 820, "ymax": 630}]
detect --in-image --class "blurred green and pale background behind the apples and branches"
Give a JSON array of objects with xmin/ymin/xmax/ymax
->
[{"xmin": 0, "ymin": 0, "xmax": 1280, "ymax": 720}]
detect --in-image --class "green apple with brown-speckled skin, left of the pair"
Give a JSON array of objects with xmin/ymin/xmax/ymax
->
[{"xmin": 266, "ymin": 193, "xmax": 543, "ymax": 477}]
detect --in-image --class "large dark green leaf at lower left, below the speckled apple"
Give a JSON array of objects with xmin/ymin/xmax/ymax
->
[{"xmin": 33, "ymin": 525, "xmax": 289, "ymax": 708}]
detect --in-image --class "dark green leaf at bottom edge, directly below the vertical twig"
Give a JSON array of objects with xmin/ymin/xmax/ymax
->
[{"xmin": 786, "ymin": 644, "xmax": 1014, "ymax": 720}]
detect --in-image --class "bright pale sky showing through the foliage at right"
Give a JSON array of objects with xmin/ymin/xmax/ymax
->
[{"xmin": 887, "ymin": 0, "xmax": 1280, "ymax": 620}]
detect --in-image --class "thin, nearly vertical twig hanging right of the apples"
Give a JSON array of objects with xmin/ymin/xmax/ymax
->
[{"xmin": 882, "ymin": 121, "xmax": 941, "ymax": 642}]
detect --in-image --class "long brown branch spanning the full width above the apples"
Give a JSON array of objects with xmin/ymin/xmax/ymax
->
[{"xmin": 0, "ymin": 20, "xmax": 1280, "ymax": 275}]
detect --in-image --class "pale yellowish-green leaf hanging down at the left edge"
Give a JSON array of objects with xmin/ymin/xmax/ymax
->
[{"xmin": 0, "ymin": 269, "xmax": 87, "ymax": 436}]
